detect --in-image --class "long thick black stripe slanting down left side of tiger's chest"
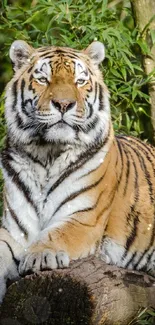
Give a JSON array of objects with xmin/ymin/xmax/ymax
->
[{"xmin": 2, "ymin": 149, "xmax": 38, "ymax": 215}]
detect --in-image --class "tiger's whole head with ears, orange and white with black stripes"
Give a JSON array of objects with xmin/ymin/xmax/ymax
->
[{"xmin": 6, "ymin": 41, "xmax": 110, "ymax": 145}]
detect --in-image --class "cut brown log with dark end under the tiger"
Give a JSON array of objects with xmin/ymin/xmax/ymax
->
[{"xmin": 0, "ymin": 257, "xmax": 155, "ymax": 325}]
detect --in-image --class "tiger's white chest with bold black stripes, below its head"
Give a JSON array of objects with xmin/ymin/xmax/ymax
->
[{"xmin": 3, "ymin": 143, "xmax": 107, "ymax": 246}]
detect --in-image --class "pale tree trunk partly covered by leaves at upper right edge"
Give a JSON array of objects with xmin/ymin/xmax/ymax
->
[{"xmin": 131, "ymin": 0, "xmax": 155, "ymax": 142}]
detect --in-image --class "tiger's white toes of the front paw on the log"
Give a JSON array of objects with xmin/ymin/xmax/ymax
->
[{"xmin": 19, "ymin": 249, "xmax": 69, "ymax": 275}]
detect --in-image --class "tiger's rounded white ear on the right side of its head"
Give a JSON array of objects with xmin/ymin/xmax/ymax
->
[{"xmin": 84, "ymin": 41, "xmax": 105, "ymax": 65}]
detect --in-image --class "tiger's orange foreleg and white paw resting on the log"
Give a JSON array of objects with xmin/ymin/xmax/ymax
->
[{"xmin": 19, "ymin": 219, "xmax": 106, "ymax": 274}]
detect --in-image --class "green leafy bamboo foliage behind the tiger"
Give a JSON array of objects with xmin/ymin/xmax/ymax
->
[{"xmin": 0, "ymin": 0, "xmax": 155, "ymax": 325}]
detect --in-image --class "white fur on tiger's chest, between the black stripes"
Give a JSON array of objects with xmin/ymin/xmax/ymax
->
[{"xmin": 4, "ymin": 143, "xmax": 108, "ymax": 246}]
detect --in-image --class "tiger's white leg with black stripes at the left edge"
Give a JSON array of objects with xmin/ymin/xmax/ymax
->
[{"xmin": 0, "ymin": 228, "xmax": 23, "ymax": 303}]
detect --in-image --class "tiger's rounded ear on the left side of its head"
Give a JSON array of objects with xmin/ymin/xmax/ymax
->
[{"xmin": 9, "ymin": 40, "xmax": 34, "ymax": 71}]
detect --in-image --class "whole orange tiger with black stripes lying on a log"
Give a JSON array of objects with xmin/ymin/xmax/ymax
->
[{"xmin": 0, "ymin": 40, "xmax": 155, "ymax": 301}]
